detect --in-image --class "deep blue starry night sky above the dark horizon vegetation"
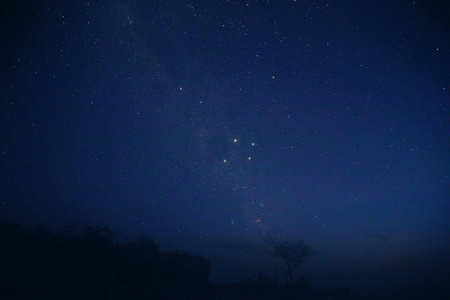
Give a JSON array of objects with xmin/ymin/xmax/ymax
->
[{"xmin": 0, "ymin": 0, "xmax": 450, "ymax": 287}]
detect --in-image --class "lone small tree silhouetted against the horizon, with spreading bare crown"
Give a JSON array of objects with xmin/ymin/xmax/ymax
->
[{"xmin": 266, "ymin": 239, "xmax": 312, "ymax": 283}]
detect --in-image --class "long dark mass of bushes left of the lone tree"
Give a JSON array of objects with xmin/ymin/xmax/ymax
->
[{"xmin": 0, "ymin": 224, "xmax": 210, "ymax": 299}]
